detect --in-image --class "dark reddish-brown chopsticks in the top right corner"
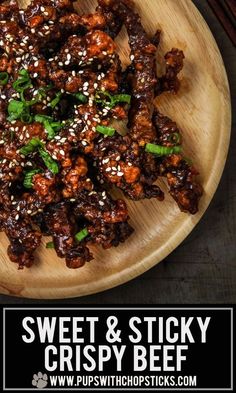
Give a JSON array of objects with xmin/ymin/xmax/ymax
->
[{"xmin": 207, "ymin": 0, "xmax": 236, "ymax": 46}]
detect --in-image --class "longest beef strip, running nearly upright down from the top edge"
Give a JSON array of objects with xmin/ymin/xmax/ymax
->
[{"xmin": 103, "ymin": 0, "xmax": 157, "ymax": 146}]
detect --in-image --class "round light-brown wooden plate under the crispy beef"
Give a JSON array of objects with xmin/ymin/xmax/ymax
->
[{"xmin": 0, "ymin": 0, "xmax": 231, "ymax": 299}]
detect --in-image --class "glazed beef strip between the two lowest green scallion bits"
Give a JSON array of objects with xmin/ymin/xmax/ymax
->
[{"xmin": 45, "ymin": 202, "xmax": 93, "ymax": 269}]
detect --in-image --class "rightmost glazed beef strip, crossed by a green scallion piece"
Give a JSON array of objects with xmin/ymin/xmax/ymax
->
[{"xmin": 153, "ymin": 111, "xmax": 203, "ymax": 214}]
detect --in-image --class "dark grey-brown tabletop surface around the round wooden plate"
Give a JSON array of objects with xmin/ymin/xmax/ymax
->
[{"xmin": 0, "ymin": 0, "xmax": 236, "ymax": 304}]
